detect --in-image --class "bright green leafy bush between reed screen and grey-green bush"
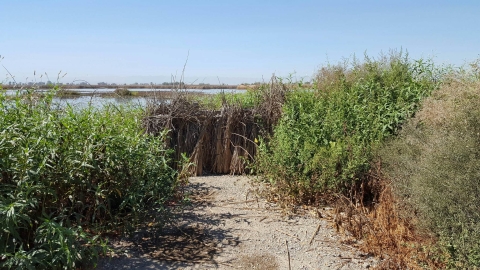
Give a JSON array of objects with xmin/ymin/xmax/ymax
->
[{"xmin": 257, "ymin": 54, "xmax": 435, "ymax": 199}]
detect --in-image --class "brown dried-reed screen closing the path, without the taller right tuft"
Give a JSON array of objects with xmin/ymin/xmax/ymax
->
[{"xmin": 146, "ymin": 97, "xmax": 259, "ymax": 175}]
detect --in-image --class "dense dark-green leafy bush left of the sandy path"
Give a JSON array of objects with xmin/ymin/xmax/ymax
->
[{"xmin": 0, "ymin": 91, "xmax": 177, "ymax": 269}]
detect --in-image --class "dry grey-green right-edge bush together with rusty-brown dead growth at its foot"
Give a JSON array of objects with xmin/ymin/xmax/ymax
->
[{"xmin": 336, "ymin": 64, "xmax": 480, "ymax": 269}]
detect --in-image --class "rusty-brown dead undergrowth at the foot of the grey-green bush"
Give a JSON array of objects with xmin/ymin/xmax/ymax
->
[{"xmin": 335, "ymin": 168, "xmax": 444, "ymax": 269}]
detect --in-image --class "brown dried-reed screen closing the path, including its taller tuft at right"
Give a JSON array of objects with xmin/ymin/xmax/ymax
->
[{"xmin": 144, "ymin": 77, "xmax": 289, "ymax": 175}]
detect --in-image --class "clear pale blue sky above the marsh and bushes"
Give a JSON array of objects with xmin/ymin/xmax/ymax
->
[{"xmin": 0, "ymin": 0, "xmax": 480, "ymax": 84}]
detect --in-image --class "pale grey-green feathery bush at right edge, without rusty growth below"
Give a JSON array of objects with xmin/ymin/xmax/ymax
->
[{"xmin": 380, "ymin": 73, "xmax": 480, "ymax": 269}]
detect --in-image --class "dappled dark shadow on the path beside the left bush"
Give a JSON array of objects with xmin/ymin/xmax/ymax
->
[{"xmin": 96, "ymin": 180, "xmax": 239, "ymax": 270}]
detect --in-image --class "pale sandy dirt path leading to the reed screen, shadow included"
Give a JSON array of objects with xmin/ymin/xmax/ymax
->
[{"xmin": 97, "ymin": 176, "xmax": 378, "ymax": 270}]
